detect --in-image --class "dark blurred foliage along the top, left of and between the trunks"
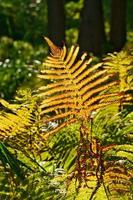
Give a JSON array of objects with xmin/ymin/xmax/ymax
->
[{"xmin": 0, "ymin": 0, "xmax": 133, "ymax": 44}]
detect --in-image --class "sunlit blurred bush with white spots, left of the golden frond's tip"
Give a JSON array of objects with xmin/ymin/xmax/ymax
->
[{"xmin": 0, "ymin": 37, "xmax": 46, "ymax": 99}]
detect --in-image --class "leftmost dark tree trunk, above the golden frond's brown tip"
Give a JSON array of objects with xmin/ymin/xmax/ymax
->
[{"xmin": 47, "ymin": 0, "xmax": 65, "ymax": 45}]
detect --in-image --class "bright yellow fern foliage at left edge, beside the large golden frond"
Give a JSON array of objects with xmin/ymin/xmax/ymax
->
[{"xmin": 0, "ymin": 89, "xmax": 44, "ymax": 156}]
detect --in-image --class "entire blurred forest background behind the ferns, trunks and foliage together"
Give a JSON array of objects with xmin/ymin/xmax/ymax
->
[{"xmin": 0, "ymin": 0, "xmax": 133, "ymax": 99}]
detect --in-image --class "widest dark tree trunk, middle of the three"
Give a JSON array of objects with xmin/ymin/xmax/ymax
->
[{"xmin": 78, "ymin": 0, "xmax": 106, "ymax": 55}]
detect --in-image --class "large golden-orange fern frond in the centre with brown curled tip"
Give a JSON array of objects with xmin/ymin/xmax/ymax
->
[{"xmin": 39, "ymin": 38, "xmax": 120, "ymax": 136}]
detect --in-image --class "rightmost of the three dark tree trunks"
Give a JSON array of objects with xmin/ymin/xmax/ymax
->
[{"xmin": 110, "ymin": 0, "xmax": 127, "ymax": 51}]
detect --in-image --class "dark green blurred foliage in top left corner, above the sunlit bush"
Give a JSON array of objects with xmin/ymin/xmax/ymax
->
[{"xmin": 0, "ymin": 0, "xmax": 47, "ymax": 44}]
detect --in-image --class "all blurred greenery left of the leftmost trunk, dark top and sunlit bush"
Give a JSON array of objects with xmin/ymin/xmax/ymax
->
[{"xmin": 0, "ymin": 0, "xmax": 47, "ymax": 99}]
